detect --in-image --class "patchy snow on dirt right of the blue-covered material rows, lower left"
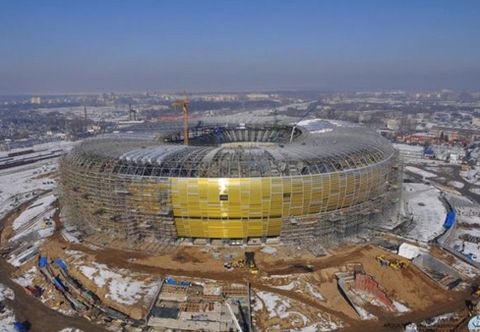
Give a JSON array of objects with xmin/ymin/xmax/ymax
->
[{"xmin": 67, "ymin": 251, "xmax": 160, "ymax": 305}]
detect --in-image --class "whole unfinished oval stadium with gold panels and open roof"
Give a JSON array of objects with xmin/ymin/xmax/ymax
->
[{"xmin": 60, "ymin": 117, "xmax": 400, "ymax": 245}]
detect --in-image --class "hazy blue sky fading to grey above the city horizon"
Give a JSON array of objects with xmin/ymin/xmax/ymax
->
[{"xmin": 0, "ymin": 0, "xmax": 480, "ymax": 95}]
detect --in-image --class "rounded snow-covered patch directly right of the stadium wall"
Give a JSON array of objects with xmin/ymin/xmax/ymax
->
[{"xmin": 403, "ymin": 183, "xmax": 447, "ymax": 242}]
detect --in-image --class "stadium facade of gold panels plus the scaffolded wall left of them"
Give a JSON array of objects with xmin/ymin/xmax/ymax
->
[{"xmin": 60, "ymin": 149, "xmax": 396, "ymax": 238}]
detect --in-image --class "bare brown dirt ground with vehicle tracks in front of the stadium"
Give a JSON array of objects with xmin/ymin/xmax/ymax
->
[{"xmin": 44, "ymin": 235, "xmax": 476, "ymax": 331}]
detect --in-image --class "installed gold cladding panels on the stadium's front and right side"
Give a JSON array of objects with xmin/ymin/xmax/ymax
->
[{"xmin": 170, "ymin": 156, "xmax": 391, "ymax": 238}]
